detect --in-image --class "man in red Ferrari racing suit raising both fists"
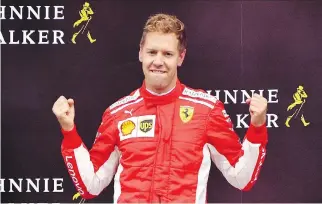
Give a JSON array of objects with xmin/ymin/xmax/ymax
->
[{"xmin": 53, "ymin": 14, "xmax": 267, "ymax": 203}]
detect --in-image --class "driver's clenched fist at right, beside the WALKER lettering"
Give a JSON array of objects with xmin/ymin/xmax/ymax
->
[{"xmin": 246, "ymin": 94, "xmax": 267, "ymax": 127}]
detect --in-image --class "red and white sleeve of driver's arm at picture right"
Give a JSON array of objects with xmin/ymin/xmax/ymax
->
[{"xmin": 206, "ymin": 101, "xmax": 267, "ymax": 190}]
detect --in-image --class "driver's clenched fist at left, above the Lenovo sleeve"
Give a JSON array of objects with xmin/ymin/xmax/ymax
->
[{"xmin": 52, "ymin": 96, "xmax": 75, "ymax": 131}]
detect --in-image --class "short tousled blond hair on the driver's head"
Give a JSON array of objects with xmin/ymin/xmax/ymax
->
[{"xmin": 140, "ymin": 13, "xmax": 187, "ymax": 52}]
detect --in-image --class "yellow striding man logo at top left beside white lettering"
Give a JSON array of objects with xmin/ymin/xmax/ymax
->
[{"xmin": 72, "ymin": 2, "xmax": 96, "ymax": 44}]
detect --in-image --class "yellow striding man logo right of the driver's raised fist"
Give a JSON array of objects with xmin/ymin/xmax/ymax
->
[{"xmin": 285, "ymin": 86, "xmax": 310, "ymax": 127}]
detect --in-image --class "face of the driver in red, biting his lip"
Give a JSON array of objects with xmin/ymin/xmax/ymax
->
[{"xmin": 139, "ymin": 32, "xmax": 186, "ymax": 93}]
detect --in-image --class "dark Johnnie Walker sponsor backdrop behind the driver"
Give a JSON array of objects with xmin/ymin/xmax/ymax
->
[{"xmin": 0, "ymin": 0, "xmax": 322, "ymax": 203}]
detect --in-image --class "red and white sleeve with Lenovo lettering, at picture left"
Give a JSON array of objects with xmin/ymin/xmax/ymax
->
[{"xmin": 61, "ymin": 111, "xmax": 119, "ymax": 199}]
